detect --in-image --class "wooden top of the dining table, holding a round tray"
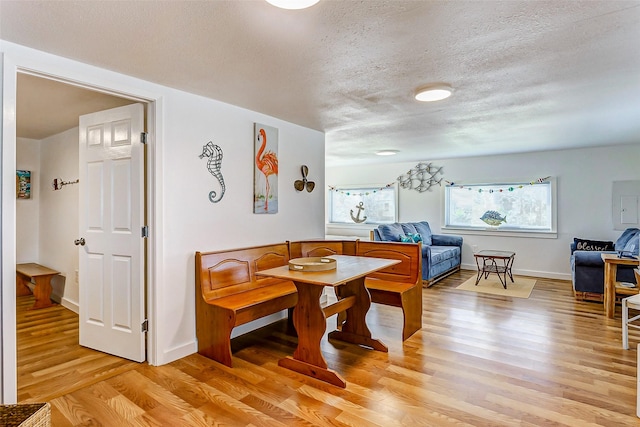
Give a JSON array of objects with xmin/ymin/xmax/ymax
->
[{"xmin": 256, "ymin": 255, "xmax": 400, "ymax": 286}]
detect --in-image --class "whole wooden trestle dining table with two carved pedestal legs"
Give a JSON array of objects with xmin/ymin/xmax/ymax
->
[{"xmin": 256, "ymin": 255, "xmax": 400, "ymax": 388}]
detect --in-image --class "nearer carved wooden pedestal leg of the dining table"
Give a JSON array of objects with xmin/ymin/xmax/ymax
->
[{"xmin": 278, "ymin": 282, "xmax": 347, "ymax": 388}]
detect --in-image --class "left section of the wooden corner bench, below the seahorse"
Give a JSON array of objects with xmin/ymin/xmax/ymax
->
[{"xmin": 196, "ymin": 242, "xmax": 298, "ymax": 367}]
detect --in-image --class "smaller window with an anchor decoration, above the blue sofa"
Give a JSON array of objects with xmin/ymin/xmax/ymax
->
[{"xmin": 329, "ymin": 183, "xmax": 398, "ymax": 224}]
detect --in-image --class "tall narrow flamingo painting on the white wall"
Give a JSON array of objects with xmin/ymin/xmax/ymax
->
[{"xmin": 253, "ymin": 123, "xmax": 278, "ymax": 214}]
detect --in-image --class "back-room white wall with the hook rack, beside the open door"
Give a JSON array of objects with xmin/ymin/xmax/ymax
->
[{"xmin": 38, "ymin": 127, "xmax": 79, "ymax": 312}]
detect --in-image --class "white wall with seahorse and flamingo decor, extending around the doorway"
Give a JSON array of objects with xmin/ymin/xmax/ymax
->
[{"xmin": 0, "ymin": 41, "xmax": 325, "ymax": 392}]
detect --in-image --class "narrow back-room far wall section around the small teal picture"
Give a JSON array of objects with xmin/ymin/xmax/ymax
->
[{"xmin": 16, "ymin": 138, "xmax": 40, "ymax": 263}]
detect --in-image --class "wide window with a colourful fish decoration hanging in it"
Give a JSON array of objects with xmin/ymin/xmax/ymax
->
[{"xmin": 444, "ymin": 178, "xmax": 556, "ymax": 237}]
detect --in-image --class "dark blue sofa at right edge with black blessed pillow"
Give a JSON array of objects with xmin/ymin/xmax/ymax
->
[{"xmin": 571, "ymin": 228, "xmax": 640, "ymax": 301}]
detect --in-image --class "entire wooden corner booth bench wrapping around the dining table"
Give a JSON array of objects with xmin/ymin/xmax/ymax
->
[{"xmin": 195, "ymin": 240, "xmax": 422, "ymax": 367}]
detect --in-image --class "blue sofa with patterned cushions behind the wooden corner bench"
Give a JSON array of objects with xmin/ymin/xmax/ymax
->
[{"xmin": 371, "ymin": 221, "xmax": 462, "ymax": 287}]
